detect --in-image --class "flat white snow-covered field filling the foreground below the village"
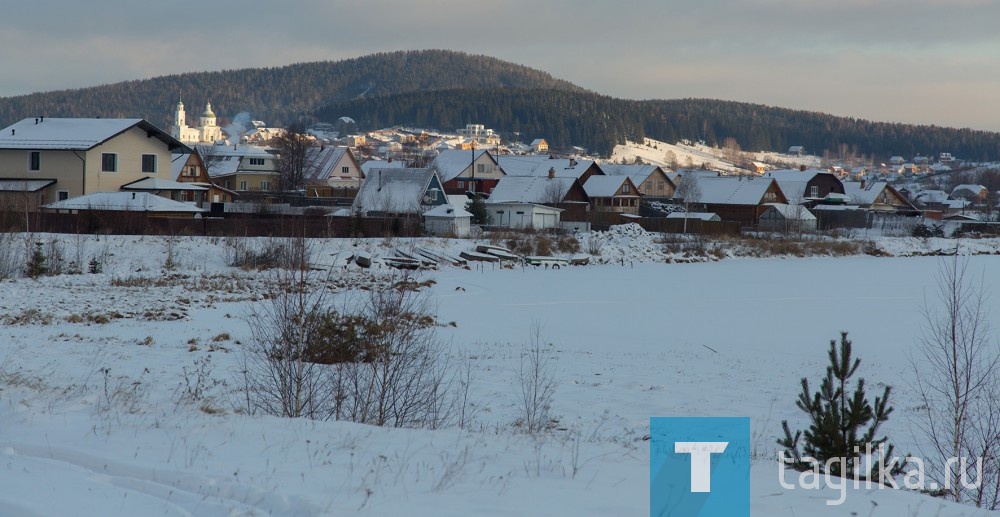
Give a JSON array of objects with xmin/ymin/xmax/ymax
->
[{"xmin": 0, "ymin": 232, "xmax": 1000, "ymax": 517}]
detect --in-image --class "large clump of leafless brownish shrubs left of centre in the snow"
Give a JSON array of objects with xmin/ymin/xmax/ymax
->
[{"xmin": 241, "ymin": 262, "xmax": 458, "ymax": 428}]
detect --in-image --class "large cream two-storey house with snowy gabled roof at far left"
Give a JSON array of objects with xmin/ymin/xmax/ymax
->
[{"xmin": 0, "ymin": 117, "xmax": 191, "ymax": 205}]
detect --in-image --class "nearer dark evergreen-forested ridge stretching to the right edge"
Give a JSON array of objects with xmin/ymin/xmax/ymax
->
[{"xmin": 317, "ymin": 88, "xmax": 1000, "ymax": 161}]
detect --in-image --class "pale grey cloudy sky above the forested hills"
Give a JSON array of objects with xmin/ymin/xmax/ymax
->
[{"xmin": 0, "ymin": 0, "xmax": 1000, "ymax": 130}]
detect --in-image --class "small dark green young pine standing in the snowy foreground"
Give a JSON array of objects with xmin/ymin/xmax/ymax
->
[{"xmin": 778, "ymin": 332, "xmax": 904, "ymax": 480}]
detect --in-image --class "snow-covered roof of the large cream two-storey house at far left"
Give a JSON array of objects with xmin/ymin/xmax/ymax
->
[{"xmin": 0, "ymin": 117, "xmax": 187, "ymax": 151}]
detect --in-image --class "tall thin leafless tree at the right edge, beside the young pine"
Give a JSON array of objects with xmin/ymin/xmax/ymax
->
[{"xmin": 910, "ymin": 253, "xmax": 1000, "ymax": 509}]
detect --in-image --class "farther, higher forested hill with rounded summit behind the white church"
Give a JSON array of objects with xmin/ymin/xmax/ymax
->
[{"xmin": 0, "ymin": 50, "xmax": 583, "ymax": 127}]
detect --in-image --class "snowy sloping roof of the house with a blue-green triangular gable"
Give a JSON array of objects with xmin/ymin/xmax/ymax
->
[{"xmin": 351, "ymin": 169, "xmax": 444, "ymax": 213}]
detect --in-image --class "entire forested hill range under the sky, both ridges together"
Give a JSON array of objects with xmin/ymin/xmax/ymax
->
[{"xmin": 0, "ymin": 50, "xmax": 1000, "ymax": 161}]
